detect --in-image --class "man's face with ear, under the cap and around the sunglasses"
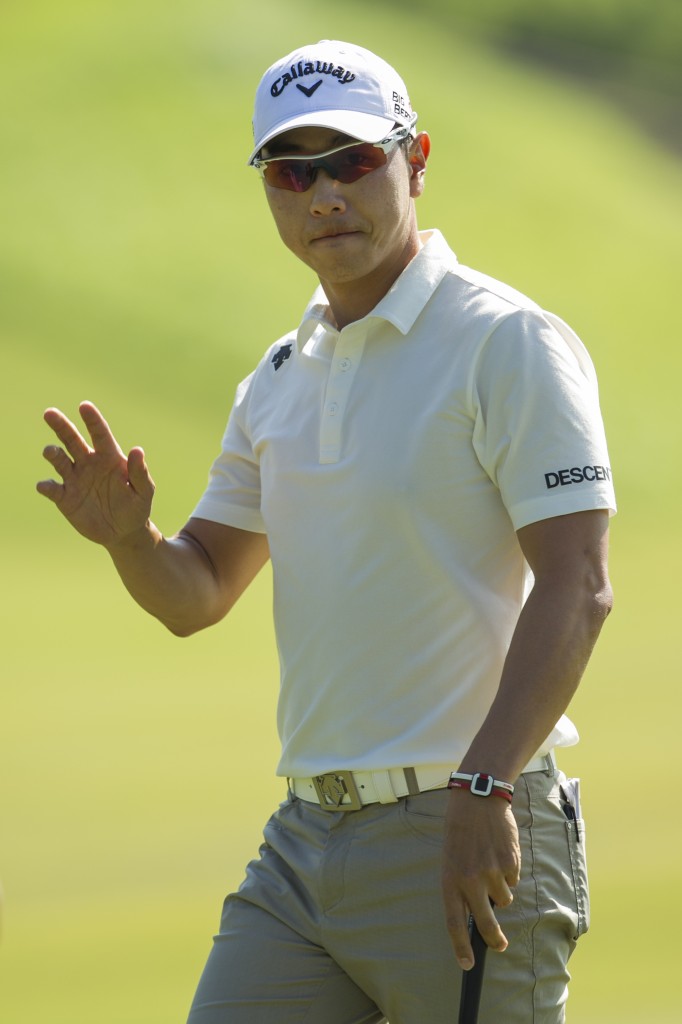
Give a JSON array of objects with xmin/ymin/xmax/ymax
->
[{"xmin": 259, "ymin": 127, "xmax": 428, "ymax": 289}]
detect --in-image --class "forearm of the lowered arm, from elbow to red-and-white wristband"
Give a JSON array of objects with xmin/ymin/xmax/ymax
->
[{"xmin": 462, "ymin": 575, "xmax": 610, "ymax": 780}]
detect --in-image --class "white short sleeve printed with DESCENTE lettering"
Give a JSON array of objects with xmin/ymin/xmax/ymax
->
[{"xmin": 472, "ymin": 309, "xmax": 615, "ymax": 529}]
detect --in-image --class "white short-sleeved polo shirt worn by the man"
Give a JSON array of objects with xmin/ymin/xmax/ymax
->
[{"xmin": 194, "ymin": 231, "xmax": 615, "ymax": 776}]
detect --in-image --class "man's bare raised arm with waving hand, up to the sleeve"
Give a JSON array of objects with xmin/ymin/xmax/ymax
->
[{"xmin": 38, "ymin": 402, "xmax": 269, "ymax": 636}]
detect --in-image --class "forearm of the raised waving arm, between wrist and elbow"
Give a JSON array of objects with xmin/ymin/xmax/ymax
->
[{"xmin": 106, "ymin": 522, "xmax": 227, "ymax": 636}]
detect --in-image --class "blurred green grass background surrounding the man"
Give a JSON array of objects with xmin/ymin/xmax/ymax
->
[{"xmin": 0, "ymin": 0, "xmax": 682, "ymax": 1024}]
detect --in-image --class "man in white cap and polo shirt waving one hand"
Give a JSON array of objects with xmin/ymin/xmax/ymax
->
[{"xmin": 39, "ymin": 41, "xmax": 614, "ymax": 1024}]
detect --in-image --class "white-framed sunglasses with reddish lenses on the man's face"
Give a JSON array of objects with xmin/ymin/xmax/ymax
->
[{"xmin": 253, "ymin": 127, "xmax": 412, "ymax": 191}]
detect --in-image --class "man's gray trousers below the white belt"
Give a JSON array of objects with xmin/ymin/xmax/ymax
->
[{"xmin": 184, "ymin": 772, "xmax": 589, "ymax": 1024}]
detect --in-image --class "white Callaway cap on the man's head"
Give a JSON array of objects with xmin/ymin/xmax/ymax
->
[{"xmin": 249, "ymin": 39, "xmax": 417, "ymax": 164}]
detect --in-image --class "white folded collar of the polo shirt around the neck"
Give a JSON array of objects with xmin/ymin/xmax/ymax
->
[{"xmin": 296, "ymin": 229, "xmax": 457, "ymax": 350}]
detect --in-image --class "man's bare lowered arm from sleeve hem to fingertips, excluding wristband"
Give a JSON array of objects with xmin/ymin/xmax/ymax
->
[{"xmin": 442, "ymin": 509, "xmax": 612, "ymax": 970}]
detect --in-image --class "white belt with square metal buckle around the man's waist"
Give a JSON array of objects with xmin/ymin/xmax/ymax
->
[{"xmin": 289, "ymin": 751, "xmax": 556, "ymax": 811}]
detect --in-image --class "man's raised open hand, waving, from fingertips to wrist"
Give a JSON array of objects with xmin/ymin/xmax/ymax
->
[{"xmin": 37, "ymin": 401, "xmax": 155, "ymax": 547}]
